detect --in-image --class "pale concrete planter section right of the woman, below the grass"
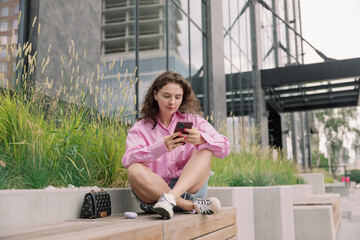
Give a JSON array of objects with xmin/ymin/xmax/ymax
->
[{"xmin": 208, "ymin": 184, "xmax": 302, "ymax": 240}]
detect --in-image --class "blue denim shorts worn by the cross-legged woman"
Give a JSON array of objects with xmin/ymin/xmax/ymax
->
[{"xmin": 132, "ymin": 178, "xmax": 209, "ymax": 213}]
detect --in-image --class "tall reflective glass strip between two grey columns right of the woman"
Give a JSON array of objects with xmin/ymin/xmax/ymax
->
[{"xmin": 223, "ymin": 0, "xmax": 255, "ymax": 124}]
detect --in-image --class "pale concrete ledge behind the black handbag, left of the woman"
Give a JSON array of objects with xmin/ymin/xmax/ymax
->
[{"xmin": 0, "ymin": 188, "xmax": 139, "ymax": 230}]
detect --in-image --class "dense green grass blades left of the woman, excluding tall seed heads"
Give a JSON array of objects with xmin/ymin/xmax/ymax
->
[{"xmin": 0, "ymin": 92, "xmax": 127, "ymax": 189}]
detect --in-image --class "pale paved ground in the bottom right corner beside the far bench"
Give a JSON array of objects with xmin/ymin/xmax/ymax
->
[{"xmin": 336, "ymin": 189, "xmax": 360, "ymax": 240}]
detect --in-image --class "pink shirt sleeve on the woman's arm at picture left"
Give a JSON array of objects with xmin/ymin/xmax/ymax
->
[{"xmin": 121, "ymin": 126, "xmax": 168, "ymax": 168}]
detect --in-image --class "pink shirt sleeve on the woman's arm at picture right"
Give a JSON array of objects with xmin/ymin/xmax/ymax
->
[{"xmin": 196, "ymin": 119, "xmax": 230, "ymax": 158}]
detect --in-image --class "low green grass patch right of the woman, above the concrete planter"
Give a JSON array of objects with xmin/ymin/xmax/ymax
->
[{"xmin": 209, "ymin": 145, "xmax": 302, "ymax": 186}]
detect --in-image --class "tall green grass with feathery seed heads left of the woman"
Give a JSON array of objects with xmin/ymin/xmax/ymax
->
[{"xmin": 0, "ymin": 14, "xmax": 135, "ymax": 189}]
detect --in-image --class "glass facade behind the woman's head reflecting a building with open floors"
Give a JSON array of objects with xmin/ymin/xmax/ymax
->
[{"xmin": 100, "ymin": 0, "xmax": 206, "ymax": 119}]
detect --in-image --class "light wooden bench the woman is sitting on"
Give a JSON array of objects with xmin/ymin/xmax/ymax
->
[{"xmin": 0, "ymin": 207, "xmax": 237, "ymax": 240}]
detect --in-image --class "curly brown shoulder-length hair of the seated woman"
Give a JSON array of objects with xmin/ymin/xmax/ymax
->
[{"xmin": 139, "ymin": 71, "xmax": 202, "ymax": 129}]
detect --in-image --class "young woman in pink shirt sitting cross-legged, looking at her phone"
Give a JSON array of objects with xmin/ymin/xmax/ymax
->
[{"xmin": 122, "ymin": 71, "xmax": 230, "ymax": 219}]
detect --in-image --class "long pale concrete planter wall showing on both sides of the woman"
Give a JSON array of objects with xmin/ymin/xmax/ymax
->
[{"xmin": 0, "ymin": 184, "xmax": 324, "ymax": 240}]
